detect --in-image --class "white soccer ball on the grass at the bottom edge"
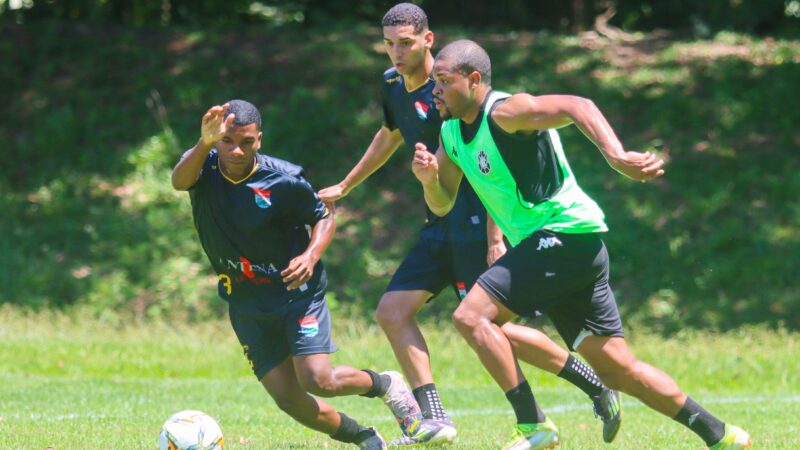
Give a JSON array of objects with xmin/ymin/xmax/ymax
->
[{"xmin": 158, "ymin": 409, "xmax": 224, "ymax": 450}]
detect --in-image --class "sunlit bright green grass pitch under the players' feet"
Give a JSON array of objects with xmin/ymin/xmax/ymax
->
[{"xmin": 0, "ymin": 307, "xmax": 800, "ymax": 450}]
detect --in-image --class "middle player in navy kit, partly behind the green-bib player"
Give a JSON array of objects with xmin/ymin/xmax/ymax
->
[{"xmin": 319, "ymin": 3, "xmax": 620, "ymax": 445}]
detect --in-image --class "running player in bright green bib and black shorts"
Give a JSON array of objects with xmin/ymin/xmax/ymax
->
[{"xmin": 412, "ymin": 40, "xmax": 751, "ymax": 450}]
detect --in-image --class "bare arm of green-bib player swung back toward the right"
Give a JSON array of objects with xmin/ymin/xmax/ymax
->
[{"xmin": 492, "ymin": 94, "xmax": 664, "ymax": 181}]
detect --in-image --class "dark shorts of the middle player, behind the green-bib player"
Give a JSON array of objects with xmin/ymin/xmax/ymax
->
[{"xmin": 386, "ymin": 237, "xmax": 487, "ymax": 299}]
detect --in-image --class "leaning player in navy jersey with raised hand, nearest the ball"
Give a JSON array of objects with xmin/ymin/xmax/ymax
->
[{"xmin": 172, "ymin": 100, "xmax": 422, "ymax": 449}]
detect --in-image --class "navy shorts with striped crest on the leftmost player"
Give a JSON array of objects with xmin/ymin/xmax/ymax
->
[{"xmin": 228, "ymin": 298, "xmax": 337, "ymax": 380}]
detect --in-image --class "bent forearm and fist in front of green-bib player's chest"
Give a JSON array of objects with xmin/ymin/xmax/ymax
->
[{"xmin": 411, "ymin": 140, "xmax": 464, "ymax": 217}]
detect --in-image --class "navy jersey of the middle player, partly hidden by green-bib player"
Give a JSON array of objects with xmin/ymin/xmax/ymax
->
[{"xmin": 381, "ymin": 68, "xmax": 486, "ymax": 242}]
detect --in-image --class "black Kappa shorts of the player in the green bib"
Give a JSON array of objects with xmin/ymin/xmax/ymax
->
[{"xmin": 478, "ymin": 230, "xmax": 623, "ymax": 350}]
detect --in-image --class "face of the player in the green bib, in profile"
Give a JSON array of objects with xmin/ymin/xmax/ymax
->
[{"xmin": 431, "ymin": 59, "xmax": 475, "ymax": 120}]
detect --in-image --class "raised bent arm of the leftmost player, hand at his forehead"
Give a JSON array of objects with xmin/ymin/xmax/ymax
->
[{"xmin": 172, "ymin": 103, "xmax": 234, "ymax": 191}]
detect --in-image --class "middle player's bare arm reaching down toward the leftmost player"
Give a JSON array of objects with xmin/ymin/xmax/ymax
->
[{"xmin": 318, "ymin": 127, "xmax": 403, "ymax": 202}]
